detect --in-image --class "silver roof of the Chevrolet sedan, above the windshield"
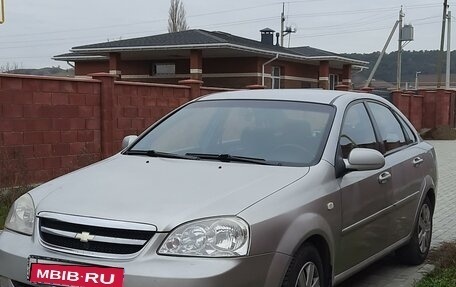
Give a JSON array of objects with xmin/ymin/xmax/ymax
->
[{"xmin": 198, "ymin": 89, "xmax": 380, "ymax": 104}]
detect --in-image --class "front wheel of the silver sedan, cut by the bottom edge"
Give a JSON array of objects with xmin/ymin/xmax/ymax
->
[{"xmin": 282, "ymin": 243, "xmax": 330, "ymax": 287}]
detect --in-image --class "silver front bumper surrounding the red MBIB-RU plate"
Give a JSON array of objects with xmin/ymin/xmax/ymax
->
[{"xmin": 0, "ymin": 230, "xmax": 291, "ymax": 287}]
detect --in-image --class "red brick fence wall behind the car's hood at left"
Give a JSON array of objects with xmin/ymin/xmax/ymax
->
[{"xmin": 0, "ymin": 74, "xmax": 224, "ymax": 187}]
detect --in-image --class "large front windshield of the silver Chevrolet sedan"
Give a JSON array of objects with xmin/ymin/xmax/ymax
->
[{"xmin": 127, "ymin": 100, "xmax": 334, "ymax": 166}]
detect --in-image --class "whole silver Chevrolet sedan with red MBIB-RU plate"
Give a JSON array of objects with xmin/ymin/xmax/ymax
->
[{"xmin": 0, "ymin": 90, "xmax": 437, "ymax": 287}]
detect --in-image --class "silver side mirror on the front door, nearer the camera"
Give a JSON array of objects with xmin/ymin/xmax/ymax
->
[{"xmin": 344, "ymin": 148, "xmax": 385, "ymax": 171}]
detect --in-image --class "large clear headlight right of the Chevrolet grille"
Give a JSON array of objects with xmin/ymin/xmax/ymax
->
[{"xmin": 158, "ymin": 217, "xmax": 250, "ymax": 257}]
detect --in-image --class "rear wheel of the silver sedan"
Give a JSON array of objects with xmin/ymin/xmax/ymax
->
[{"xmin": 396, "ymin": 197, "xmax": 433, "ymax": 265}]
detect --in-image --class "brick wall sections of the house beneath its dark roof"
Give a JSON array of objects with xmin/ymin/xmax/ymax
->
[{"xmin": 76, "ymin": 57, "xmax": 342, "ymax": 89}]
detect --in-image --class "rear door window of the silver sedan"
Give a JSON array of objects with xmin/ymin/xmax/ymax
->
[{"xmin": 368, "ymin": 103, "xmax": 407, "ymax": 152}]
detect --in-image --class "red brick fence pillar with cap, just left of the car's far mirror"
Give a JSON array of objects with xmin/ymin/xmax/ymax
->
[{"xmin": 90, "ymin": 73, "xmax": 118, "ymax": 158}]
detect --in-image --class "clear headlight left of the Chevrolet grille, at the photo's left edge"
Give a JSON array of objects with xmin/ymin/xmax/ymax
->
[{"xmin": 5, "ymin": 193, "xmax": 35, "ymax": 235}]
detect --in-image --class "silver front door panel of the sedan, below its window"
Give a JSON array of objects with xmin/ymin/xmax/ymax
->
[{"xmin": 335, "ymin": 166, "xmax": 392, "ymax": 274}]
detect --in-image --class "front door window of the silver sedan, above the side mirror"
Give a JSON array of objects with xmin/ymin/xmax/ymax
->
[{"xmin": 340, "ymin": 103, "xmax": 378, "ymax": 158}]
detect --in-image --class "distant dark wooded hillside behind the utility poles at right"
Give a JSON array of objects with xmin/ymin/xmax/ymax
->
[{"xmin": 343, "ymin": 50, "xmax": 456, "ymax": 88}]
